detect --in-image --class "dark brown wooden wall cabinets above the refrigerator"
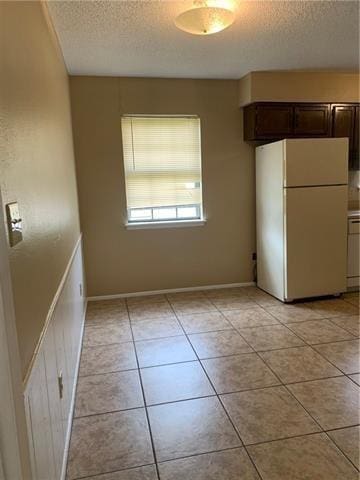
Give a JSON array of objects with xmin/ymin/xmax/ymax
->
[{"xmin": 244, "ymin": 102, "xmax": 360, "ymax": 169}]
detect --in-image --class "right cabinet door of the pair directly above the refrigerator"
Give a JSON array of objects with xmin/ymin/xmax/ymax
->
[{"xmin": 294, "ymin": 105, "xmax": 330, "ymax": 137}]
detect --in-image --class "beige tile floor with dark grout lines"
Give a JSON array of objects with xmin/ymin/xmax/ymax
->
[{"xmin": 67, "ymin": 287, "xmax": 360, "ymax": 480}]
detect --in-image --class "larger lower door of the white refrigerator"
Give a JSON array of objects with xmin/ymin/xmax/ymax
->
[{"xmin": 284, "ymin": 185, "xmax": 348, "ymax": 301}]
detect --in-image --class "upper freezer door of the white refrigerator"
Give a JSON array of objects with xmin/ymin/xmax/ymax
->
[{"xmin": 284, "ymin": 138, "xmax": 348, "ymax": 187}]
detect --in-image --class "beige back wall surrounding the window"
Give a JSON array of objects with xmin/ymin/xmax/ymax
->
[{"xmin": 70, "ymin": 77, "xmax": 255, "ymax": 295}]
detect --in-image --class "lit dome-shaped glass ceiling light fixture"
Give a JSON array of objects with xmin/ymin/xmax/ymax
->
[{"xmin": 175, "ymin": 0, "xmax": 235, "ymax": 35}]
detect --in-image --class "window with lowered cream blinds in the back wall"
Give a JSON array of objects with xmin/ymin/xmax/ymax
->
[{"xmin": 121, "ymin": 115, "xmax": 202, "ymax": 224}]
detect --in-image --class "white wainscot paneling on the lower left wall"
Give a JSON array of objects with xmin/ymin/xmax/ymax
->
[{"xmin": 24, "ymin": 241, "xmax": 86, "ymax": 480}]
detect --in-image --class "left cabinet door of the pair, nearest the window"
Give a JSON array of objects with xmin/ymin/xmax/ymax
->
[{"xmin": 256, "ymin": 105, "xmax": 293, "ymax": 139}]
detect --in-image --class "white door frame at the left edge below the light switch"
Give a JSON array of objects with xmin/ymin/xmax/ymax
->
[{"xmin": 0, "ymin": 192, "xmax": 32, "ymax": 480}]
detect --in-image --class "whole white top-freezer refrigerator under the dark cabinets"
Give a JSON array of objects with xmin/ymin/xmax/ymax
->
[{"xmin": 256, "ymin": 138, "xmax": 348, "ymax": 302}]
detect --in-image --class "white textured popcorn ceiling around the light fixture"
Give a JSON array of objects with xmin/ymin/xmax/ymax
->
[{"xmin": 48, "ymin": 0, "xmax": 359, "ymax": 78}]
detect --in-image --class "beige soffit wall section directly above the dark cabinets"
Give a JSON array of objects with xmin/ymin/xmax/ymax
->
[{"xmin": 239, "ymin": 71, "xmax": 360, "ymax": 106}]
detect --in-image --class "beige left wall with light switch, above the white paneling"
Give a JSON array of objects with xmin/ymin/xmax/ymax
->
[{"xmin": 0, "ymin": 2, "xmax": 79, "ymax": 375}]
